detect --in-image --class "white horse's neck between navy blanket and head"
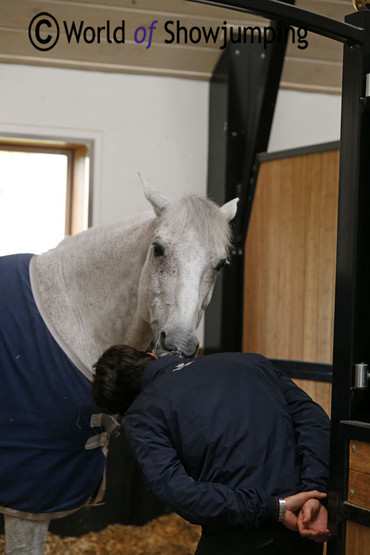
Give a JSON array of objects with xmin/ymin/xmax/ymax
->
[{"xmin": 33, "ymin": 216, "xmax": 154, "ymax": 370}]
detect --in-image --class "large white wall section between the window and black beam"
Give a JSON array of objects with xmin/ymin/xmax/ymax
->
[{"xmin": 0, "ymin": 64, "xmax": 208, "ymax": 224}]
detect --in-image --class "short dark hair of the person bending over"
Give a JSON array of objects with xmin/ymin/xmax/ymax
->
[{"xmin": 91, "ymin": 345, "xmax": 153, "ymax": 414}]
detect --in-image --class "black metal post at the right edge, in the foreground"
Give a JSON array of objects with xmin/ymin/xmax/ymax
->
[{"xmin": 328, "ymin": 11, "xmax": 370, "ymax": 555}]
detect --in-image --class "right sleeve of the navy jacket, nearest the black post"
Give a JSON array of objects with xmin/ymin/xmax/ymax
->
[{"xmin": 276, "ymin": 370, "xmax": 330, "ymax": 492}]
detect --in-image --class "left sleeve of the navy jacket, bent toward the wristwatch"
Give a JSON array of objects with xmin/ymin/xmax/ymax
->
[{"xmin": 124, "ymin": 400, "xmax": 277, "ymax": 528}]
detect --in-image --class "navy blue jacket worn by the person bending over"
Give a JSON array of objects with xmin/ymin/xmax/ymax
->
[{"xmin": 124, "ymin": 353, "xmax": 329, "ymax": 528}]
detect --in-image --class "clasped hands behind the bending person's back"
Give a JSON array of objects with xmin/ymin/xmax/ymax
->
[{"xmin": 283, "ymin": 490, "xmax": 330, "ymax": 542}]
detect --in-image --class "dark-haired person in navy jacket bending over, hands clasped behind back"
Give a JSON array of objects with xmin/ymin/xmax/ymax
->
[{"xmin": 92, "ymin": 345, "xmax": 330, "ymax": 555}]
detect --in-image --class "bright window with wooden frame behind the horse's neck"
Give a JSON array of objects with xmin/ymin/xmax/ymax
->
[{"xmin": 0, "ymin": 140, "xmax": 89, "ymax": 256}]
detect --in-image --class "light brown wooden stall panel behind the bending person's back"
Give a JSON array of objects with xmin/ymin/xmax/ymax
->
[{"xmin": 243, "ymin": 143, "xmax": 339, "ymax": 415}]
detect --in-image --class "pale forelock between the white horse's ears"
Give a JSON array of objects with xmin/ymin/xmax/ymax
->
[{"xmin": 158, "ymin": 195, "xmax": 231, "ymax": 251}]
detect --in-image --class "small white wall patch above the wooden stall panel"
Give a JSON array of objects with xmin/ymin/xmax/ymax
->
[{"xmin": 268, "ymin": 90, "xmax": 341, "ymax": 152}]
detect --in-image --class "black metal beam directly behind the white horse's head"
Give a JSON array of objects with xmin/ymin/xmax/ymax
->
[{"xmin": 204, "ymin": 11, "xmax": 294, "ymax": 354}]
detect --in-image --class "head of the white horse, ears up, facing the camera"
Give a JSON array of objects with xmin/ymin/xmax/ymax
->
[{"xmin": 138, "ymin": 182, "xmax": 238, "ymax": 357}]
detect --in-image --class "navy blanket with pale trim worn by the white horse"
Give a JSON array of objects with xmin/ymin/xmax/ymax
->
[{"xmin": 0, "ymin": 254, "xmax": 109, "ymax": 519}]
